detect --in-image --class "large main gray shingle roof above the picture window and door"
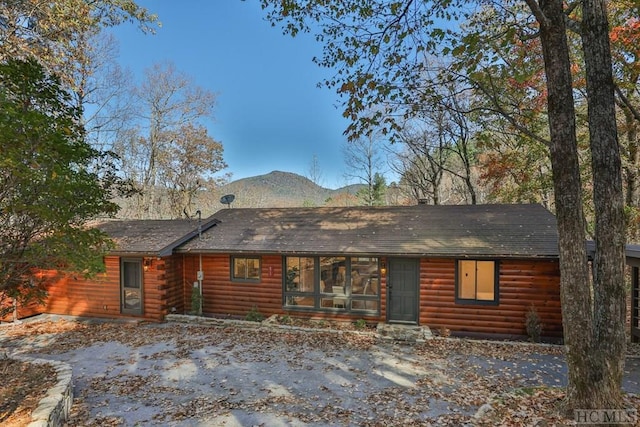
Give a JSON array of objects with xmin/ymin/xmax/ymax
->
[{"xmin": 177, "ymin": 205, "xmax": 558, "ymax": 258}]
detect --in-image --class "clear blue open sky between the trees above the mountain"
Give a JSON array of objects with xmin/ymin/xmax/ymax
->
[{"xmin": 107, "ymin": 0, "xmax": 362, "ymax": 188}]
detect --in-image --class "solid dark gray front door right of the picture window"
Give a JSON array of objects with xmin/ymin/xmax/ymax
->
[{"xmin": 387, "ymin": 258, "xmax": 419, "ymax": 324}]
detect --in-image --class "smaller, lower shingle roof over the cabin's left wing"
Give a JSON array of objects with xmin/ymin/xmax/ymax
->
[{"xmin": 96, "ymin": 219, "xmax": 215, "ymax": 256}]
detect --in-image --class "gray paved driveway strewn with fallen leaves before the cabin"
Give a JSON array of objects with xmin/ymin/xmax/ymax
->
[{"xmin": 0, "ymin": 320, "xmax": 640, "ymax": 426}]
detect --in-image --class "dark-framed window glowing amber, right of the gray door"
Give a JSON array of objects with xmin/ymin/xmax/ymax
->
[{"xmin": 456, "ymin": 260, "xmax": 498, "ymax": 304}]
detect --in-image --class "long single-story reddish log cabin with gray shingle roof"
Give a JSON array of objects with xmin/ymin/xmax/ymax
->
[{"xmin": 2, "ymin": 204, "xmax": 562, "ymax": 338}]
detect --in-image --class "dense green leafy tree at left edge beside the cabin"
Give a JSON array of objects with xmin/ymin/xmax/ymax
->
[{"xmin": 0, "ymin": 59, "xmax": 120, "ymax": 317}]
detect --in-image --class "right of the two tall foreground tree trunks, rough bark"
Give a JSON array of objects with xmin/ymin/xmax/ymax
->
[{"xmin": 572, "ymin": 0, "xmax": 626, "ymax": 408}]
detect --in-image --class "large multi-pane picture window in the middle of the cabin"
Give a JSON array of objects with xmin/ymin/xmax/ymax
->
[{"xmin": 283, "ymin": 256, "xmax": 380, "ymax": 312}]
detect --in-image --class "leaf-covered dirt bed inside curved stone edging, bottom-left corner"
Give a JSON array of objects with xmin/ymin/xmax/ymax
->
[{"xmin": 0, "ymin": 358, "xmax": 57, "ymax": 426}]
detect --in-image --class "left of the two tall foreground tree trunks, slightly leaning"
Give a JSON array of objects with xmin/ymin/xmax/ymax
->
[{"xmin": 529, "ymin": 0, "xmax": 593, "ymax": 411}]
